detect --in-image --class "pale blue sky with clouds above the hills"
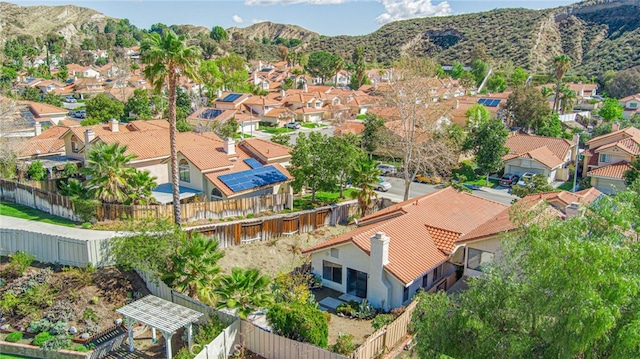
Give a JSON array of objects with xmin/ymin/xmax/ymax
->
[{"xmin": 3, "ymin": 0, "xmax": 577, "ymax": 36}]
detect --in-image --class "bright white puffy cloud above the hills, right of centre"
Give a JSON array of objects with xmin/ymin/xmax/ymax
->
[{"xmin": 376, "ymin": 0, "xmax": 452, "ymax": 24}]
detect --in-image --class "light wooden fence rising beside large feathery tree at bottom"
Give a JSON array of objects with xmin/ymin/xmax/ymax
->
[{"xmin": 349, "ymin": 300, "xmax": 418, "ymax": 359}]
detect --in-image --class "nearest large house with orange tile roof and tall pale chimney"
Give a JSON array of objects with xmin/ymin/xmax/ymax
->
[{"xmin": 304, "ymin": 187, "xmax": 515, "ymax": 310}]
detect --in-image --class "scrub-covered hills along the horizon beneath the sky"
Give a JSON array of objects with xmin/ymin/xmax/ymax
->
[{"xmin": 0, "ymin": 0, "xmax": 640, "ymax": 76}]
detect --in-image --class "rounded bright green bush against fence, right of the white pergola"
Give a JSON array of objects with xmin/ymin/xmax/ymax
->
[{"xmin": 267, "ymin": 303, "xmax": 329, "ymax": 348}]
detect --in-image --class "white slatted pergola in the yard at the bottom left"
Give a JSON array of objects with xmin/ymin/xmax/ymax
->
[{"xmin": 116, "ymin": 295, "xmax": 204, "ymax": 359}]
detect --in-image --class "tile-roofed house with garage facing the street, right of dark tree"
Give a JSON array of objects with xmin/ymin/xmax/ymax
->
[{"xmin": 502, "ymin": 133, "xmax": 578, "ymax": 183}]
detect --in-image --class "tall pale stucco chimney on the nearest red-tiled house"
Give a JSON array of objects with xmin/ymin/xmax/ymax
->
[{"xmin": 367, "ymin": 232, "xmax": 392, "ymax": 310}]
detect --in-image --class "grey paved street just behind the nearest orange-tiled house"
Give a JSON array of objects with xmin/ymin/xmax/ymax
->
[{"xmin": 377, "ymin": 177, "xmax": 518, "ymax": 204}]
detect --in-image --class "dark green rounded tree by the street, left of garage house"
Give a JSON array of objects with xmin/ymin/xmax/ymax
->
[{"xmin": 465, "ymin": 119, "xmax": 509, "ymax": 184}]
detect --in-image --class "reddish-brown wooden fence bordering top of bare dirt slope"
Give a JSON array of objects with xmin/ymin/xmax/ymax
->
[{"xmin": 190, "ymin": 199, "xmax": 391, "ymax": 248}]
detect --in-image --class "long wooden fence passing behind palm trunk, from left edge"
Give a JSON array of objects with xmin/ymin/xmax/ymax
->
[{"xmin": 0, "ymin": 179, "xmax": 293, "ymax": 223}]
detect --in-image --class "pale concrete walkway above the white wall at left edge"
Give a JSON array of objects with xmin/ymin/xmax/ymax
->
[{"xmin": 0, "ymin": 216, "xmax": 121, "ymax": 241}]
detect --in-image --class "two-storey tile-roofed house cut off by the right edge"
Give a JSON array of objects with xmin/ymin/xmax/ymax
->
[{"xmin": 582, "ymin": 123, "xmax": 640, "ymax": 194}]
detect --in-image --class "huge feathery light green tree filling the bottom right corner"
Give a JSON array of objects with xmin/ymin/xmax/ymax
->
[{"xmin": 413, "ymin": 188, "xmax": 640, "ymax": 358}]
